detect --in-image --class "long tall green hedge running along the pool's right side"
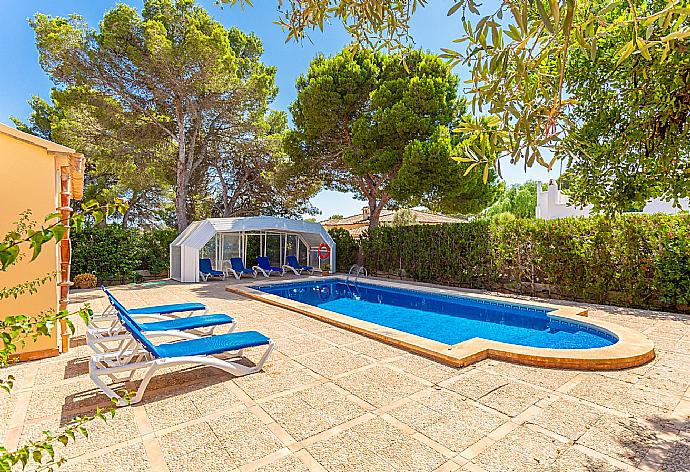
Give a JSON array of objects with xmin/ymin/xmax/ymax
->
[{"xmin": 361, "ymin": 214, "xmax": 690, "ymax": 311}]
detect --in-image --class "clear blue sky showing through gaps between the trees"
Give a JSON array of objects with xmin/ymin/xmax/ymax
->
[{"xmin": 0, "ymin": 0, "xmax": 559, "ymax": 219}]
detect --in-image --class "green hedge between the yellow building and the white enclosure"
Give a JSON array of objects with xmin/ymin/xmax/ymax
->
[{"xmin": 72, "ymin": 225, "xmax": 177, "ymax": 285}]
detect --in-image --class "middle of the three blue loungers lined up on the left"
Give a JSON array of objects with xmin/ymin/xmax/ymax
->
[{"xmin": 86, "ymin": 287, "xmax": 236, "ymax": 353}]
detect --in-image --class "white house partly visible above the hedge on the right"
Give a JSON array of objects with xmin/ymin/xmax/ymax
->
[{"xmin": 536, "ymin": 180, "xmax": 690, "ymax": 220}]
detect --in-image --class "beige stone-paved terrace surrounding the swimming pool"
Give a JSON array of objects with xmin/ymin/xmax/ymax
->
[{"xmin": 0, "ymin": 276, "xmax": 690, "ymax": 472}]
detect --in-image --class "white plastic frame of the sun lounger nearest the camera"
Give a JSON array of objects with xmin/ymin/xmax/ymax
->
[{"xmin": 89, "ymin": 331, "xmax": 275, "ymax": 406}]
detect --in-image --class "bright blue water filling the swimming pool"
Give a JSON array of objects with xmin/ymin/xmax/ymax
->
[{"xmin": 258, "ymin": 280, "xmax": 617, "ymax": 349}]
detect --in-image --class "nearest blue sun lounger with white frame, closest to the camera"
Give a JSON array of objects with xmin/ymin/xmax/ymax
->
[{"xmin": 89, "ymin": 304, "xmax": 274, "ymax": 406}]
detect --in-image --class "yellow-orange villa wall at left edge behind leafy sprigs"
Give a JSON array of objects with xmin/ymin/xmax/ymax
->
[{"xmin": 0, "ymin": 134, "xmax": 59, "ymax": 358}]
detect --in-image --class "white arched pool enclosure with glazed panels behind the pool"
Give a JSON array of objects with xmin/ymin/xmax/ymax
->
[{"xmin": 170, "ymin": 216, "xmax": 336, "ymax": 282}]
